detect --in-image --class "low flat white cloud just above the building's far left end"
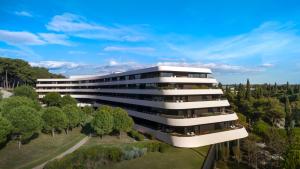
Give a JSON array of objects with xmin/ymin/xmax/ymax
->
[{"xmin": 30, "ymin": 61, "xmax": 83, "ymax": 69}]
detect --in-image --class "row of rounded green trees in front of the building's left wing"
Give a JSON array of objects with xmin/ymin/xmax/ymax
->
[{"xmin": 0, "ymin": 86, "xmax": 133, "ymax": 148}]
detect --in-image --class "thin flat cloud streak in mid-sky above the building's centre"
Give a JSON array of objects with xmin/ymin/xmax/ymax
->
[{"xmin": 103, "ymin": 46, "xmax": 155, "ymax": 53}]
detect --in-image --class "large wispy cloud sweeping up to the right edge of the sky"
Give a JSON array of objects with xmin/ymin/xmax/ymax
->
[{"xmin": 169, "ymin": 22, "xmax": 300, "ymax": 60}]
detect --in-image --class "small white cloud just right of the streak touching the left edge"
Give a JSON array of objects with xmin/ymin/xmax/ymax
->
[{"xmin": 39, "ymin": 33, "xmax": 71, "ymax": 46}]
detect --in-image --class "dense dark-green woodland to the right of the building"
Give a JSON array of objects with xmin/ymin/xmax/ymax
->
[{"xmin": 219, "ymin": 80, "xmax": 300, "ymax": 169}]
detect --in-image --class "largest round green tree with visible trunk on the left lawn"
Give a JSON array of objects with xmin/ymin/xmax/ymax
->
[{"xmin": 5, "ymin": 106, "xmax": 42, "ymax": 148}]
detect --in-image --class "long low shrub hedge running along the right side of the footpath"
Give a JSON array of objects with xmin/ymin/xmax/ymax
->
[{"xmin": 44, "ymin": 141, "xmax": 170, "ymax": 169}]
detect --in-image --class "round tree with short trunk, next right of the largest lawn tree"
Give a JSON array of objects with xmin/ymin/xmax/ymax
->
[{"xmin": 42, "ymin": 107, "xmax": 68, "ymax": 137}]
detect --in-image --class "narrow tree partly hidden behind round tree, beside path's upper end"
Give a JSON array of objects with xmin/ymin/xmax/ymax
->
[{"xmin": 62, "ymin": 104, "xmax": 82, "ymax": 133}]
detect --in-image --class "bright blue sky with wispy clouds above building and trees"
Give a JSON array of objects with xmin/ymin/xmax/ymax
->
[{"xmin": 0, "ymin": 0, "xmax": 300, "ymax": 83}]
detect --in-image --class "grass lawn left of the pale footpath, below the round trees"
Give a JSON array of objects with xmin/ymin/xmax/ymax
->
[{"xmin": 0, "ymin": 128, "xmax": 85, "ymax": 169}]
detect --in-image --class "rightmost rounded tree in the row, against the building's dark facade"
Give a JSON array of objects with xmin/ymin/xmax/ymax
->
[{"xmin": 113, "ymin": 108, "xmax": 133, "ymax": 137}]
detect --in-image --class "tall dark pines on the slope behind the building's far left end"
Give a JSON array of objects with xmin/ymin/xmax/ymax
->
[{"xmin": 0, "ymin": 57, "xmax": 64, "ymax": 88}]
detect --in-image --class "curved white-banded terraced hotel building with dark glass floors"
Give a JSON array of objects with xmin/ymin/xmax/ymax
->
[{"xmin": 36, "ymin": 66, "xmax": 248, "ymax": 147}]
